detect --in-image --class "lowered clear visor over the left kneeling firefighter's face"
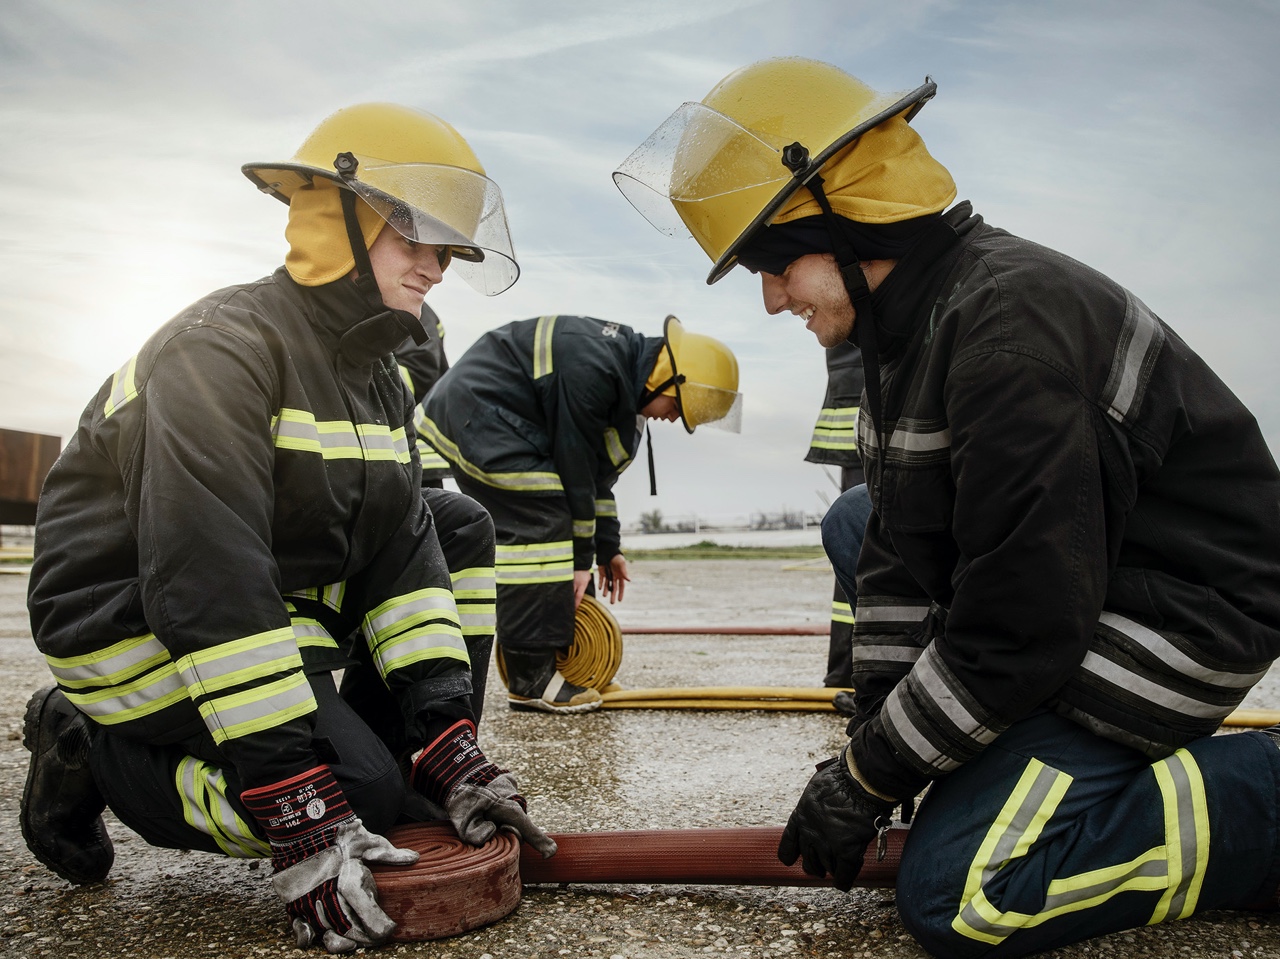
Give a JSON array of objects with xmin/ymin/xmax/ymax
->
[{"xmin": 342, "ymin": 156, "xmax": 520, "ymax": 296}]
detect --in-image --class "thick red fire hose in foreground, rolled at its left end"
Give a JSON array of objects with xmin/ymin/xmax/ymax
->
[{"xmin": 372, "ymin": 823, "xmax": 908, "ymax": 942}]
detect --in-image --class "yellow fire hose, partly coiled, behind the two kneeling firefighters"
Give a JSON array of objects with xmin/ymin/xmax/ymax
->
[{"xmin": 497, "ymin": 595, "xmax": 1280, "ymax": 729}]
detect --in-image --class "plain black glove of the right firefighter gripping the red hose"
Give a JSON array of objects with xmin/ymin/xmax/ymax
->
[{"xmin": 778, "ymin": 746, "xmax": 896, "ymax": 892}]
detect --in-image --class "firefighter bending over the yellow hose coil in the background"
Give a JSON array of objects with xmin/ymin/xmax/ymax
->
[{"xmin": 420, "ymin": 316, "xmax": 741, "ymax": 713}]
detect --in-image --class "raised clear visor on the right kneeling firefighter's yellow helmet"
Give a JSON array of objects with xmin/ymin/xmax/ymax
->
[{"xmin": 613, "ymin": 102, "xmax": 791, "ymax": 237}]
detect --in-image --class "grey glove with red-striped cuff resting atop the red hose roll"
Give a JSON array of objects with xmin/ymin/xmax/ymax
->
[{"xmin": 410, "ymin": 720, "xmax": 556, "ymax": 859}]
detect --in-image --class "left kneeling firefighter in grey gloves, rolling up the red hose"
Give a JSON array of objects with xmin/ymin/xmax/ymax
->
[{"xmin": 20, "ymin": 104, "xmax": 554, "ymax": 951}]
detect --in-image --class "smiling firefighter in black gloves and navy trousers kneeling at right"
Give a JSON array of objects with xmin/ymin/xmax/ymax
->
[{"xmin": 616, "ymin": 59, "xmax": 1280, "ymax": 956}]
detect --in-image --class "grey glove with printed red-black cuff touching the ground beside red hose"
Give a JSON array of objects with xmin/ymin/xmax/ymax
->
[{"xmin": 241, "ymin": 766, "xmax": 417, "ymax": 953}]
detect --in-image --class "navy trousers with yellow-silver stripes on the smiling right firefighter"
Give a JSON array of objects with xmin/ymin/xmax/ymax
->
[{"xmin": 897, "ymin": 711, "xmax": 1280, "ymax": 959}]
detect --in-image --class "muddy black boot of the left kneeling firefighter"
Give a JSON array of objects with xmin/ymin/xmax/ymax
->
[{"xmin": 18, "ymin": 686, "xmax": 115, "ymax": 886}]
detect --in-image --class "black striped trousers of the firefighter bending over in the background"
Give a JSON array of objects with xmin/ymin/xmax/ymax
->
[{"xmin": 454, "ymin": 476, "xmax": 573, "ymax": 650}]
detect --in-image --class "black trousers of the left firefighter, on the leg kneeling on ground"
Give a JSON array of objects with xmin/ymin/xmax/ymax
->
[{"xmin": 90, "ymin": 672, "xmax": 404, "ymax": 858}]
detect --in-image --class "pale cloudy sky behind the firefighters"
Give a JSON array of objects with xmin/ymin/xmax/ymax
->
[{"xmin": 0, "ymin": 0, "xmax": 1280, "ymax": 521}]
